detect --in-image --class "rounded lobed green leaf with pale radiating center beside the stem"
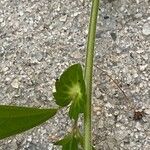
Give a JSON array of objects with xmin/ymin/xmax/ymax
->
[{"xmin": 53, "ymin": 64, "xmax": 86, "ymax": 120}]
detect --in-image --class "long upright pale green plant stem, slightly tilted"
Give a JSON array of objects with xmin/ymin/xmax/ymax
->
[{"xmin": 84, "ymin": 0, "xmax": 99, "ymax": 150}]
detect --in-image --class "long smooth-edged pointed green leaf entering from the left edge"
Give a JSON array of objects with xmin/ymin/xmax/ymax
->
[{"xmin": 0, "ymin": 105, "xmax": 57, "ymax": 139}]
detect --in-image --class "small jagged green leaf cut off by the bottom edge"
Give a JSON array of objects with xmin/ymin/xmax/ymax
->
[{"xmin": 55, "ymin": 134, "xmax": 78, "ymax": 150}]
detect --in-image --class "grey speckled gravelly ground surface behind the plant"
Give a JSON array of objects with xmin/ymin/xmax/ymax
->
[{"xmin": 0, "ymin": 0, "xmax": 150, "ymax": 150}]
